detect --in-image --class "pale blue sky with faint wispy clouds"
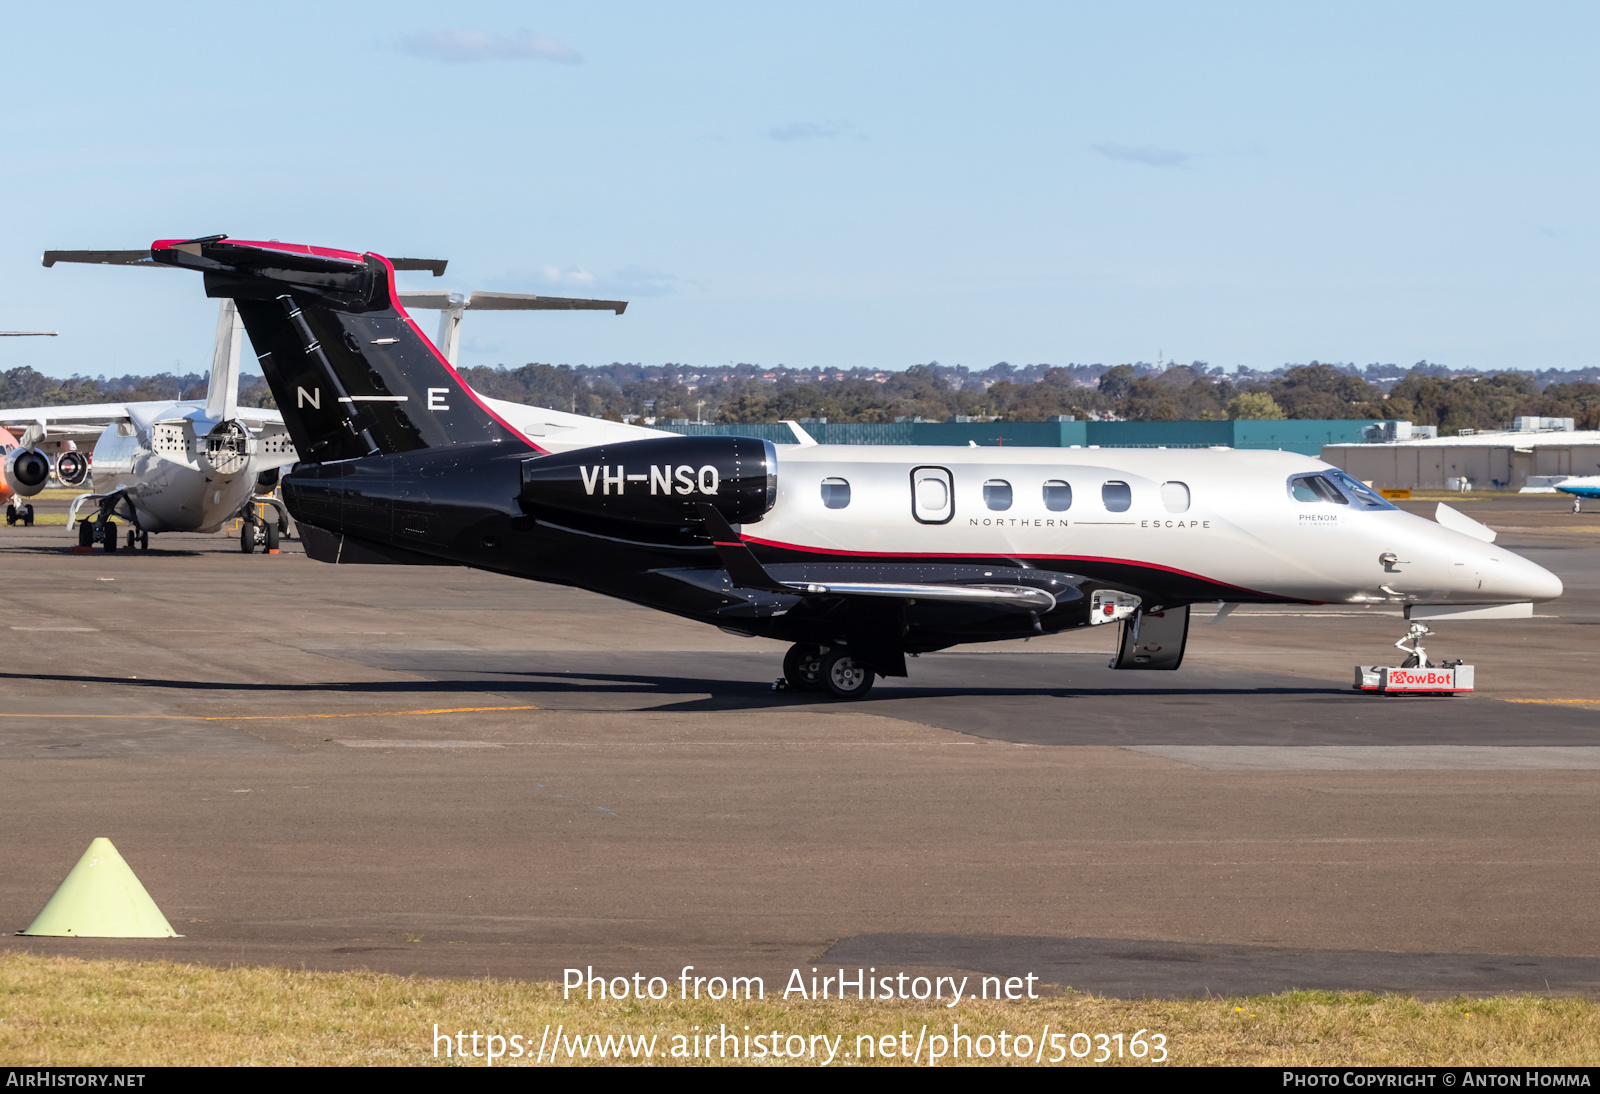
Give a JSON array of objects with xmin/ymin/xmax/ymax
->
[{"xmin": 0, "ymin": 0, "xmax": 1600, "ymax": 376}]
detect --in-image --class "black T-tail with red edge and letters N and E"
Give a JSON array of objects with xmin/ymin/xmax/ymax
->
[{"xmin": 150, "ymin": 235, "xmax": 539, "ymax": 464}]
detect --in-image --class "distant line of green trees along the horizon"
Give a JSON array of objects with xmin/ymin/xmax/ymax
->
[{"xmin": 9, "ymin": 361, "xmax": 1600, "ymax": 433}]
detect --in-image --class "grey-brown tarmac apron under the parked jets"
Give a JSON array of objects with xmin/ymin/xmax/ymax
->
[{"xmin": 0, "ymin": 496, "xmax": 1600, "ymax": 996}]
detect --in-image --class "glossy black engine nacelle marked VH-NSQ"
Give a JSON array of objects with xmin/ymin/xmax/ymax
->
[{"xmin": 522, "ymin": 437, "xmax": 778, "ymax": 525}]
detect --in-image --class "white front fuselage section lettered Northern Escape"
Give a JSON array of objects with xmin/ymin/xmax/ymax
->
[{"xmin": 744, "ymin": 445, "xmax": 1562, "ymax": 603}]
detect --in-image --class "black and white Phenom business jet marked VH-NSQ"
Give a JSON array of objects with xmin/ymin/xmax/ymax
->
[{"xmin": 152, "ymin": 237, "xmax": 1562, "ymax": 699}]
